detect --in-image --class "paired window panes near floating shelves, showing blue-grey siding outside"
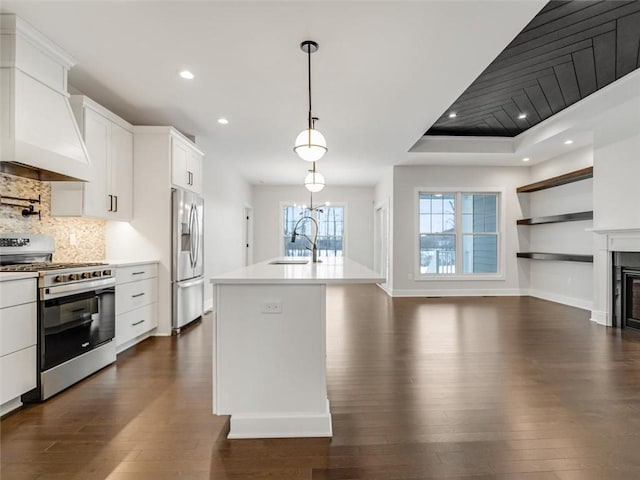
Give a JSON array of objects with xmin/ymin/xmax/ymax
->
[{"xmin": 418, "ymin": 192, "xmax": 500, "ymax": 278}]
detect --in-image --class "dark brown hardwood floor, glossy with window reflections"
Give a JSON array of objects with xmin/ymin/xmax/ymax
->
[{"xmin": 1, "ymin": 286, "xmax": 640, "ymax": 480}]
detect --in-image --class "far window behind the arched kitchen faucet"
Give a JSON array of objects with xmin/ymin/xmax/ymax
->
[{"xmin": 282, "ymin": 205, "xmax": 344, "ymax": 257}]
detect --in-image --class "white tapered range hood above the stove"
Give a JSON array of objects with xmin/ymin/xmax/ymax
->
[{"xmin": 0, "ymin": 14, "xmax": 92, "ymax": 181}]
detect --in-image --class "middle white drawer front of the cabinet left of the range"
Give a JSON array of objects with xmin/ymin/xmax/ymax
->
[{"xmin": 0, "ymin": 302, "xmax": 37, "ymax": 356}]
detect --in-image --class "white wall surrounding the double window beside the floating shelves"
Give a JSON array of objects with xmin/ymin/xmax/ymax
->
[{"xmin": 392, "ymin": 166, "xmax": 529, "ymax": 295}]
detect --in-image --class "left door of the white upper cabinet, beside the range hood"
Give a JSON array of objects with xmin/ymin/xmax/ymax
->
[{"xmin": 82, "ymin": 108, "xmax": 111, "ymax": 218}]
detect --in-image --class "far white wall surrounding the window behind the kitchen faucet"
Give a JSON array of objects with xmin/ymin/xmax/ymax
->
[{"xmin": 253, "ymin": 185, "xmax": 374, "ymax": 268}]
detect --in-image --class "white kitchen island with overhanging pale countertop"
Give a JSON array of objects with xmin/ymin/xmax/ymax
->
[{"xmin": 211, "ymin": 258, "xmax": 385, "ymax": 438}]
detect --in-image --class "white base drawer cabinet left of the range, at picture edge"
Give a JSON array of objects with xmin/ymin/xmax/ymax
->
[{"xmin": 0, "ymin": 278, "xmax": 37, "ymax": 415}]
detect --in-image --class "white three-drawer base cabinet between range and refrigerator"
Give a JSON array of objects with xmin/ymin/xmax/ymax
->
[{"xmin": 116, "ymin": 262, "xmax": 158, "ymax": 353}]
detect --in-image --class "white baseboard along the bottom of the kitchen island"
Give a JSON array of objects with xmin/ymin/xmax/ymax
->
[{"xmin": 227, "ymin": 400, "xmax": 333, "ymax": 439}]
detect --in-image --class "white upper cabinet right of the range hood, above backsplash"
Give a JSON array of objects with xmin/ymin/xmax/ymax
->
[{"xmin": 51, "ymin": 95, "xmax": 133, "ymax": 221}]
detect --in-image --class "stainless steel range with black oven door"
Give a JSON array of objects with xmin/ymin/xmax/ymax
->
[{"xmin": 0, "ymin": 234, "xmax": 116, "ymax": 402}]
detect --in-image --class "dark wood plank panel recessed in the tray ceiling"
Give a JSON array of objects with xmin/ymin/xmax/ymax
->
[{"xmin": 426, "ymin": 0, "xmax": 640, "ymax": 136}]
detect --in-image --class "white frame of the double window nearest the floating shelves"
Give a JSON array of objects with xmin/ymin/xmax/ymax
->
[{"xmin": 413, "ymin": 187, "xmax": 506, "ymax": 281}]
